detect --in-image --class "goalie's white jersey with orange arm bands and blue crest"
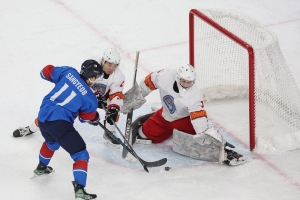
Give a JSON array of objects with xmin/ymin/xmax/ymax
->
[{"xmin": 140, "ymin": 69, "xmax": 207, "ymax": 133}]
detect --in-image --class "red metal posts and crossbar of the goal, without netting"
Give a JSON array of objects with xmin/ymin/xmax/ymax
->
[{"xmin": 189, "ymin": 9, "xmax": 255, "ymax": 151}]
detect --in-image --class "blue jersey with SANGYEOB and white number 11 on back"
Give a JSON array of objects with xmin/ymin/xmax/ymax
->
[{"xmin": 38, "ymin": 65, "xmax": 98, "ymax": 123}]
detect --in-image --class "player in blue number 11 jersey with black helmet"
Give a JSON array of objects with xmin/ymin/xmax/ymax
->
[{"xmin": 34, "ymin": 60, "xmax": 103, "ymax": 199}]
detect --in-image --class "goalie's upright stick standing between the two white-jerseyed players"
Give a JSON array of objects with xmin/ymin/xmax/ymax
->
[{"xmin": 122, "ymin": 51, "xmax": 140, "ymax": 159}]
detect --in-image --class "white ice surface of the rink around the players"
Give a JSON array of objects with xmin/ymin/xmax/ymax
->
[{"xmin": 0, "ymin": 0, "xmax": 300, "ymax": 200}]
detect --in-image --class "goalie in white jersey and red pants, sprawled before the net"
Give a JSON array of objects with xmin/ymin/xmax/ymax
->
[{"xmin": 131, "ymin": 64, "xmax": 244, "ymax": 165}]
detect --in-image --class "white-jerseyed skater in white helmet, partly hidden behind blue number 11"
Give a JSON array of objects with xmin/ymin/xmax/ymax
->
[{"xmin": 13, "ymin": 48, "xmax": 125, "ymax": 148}]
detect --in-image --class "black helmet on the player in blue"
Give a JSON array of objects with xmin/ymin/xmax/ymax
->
[{"xmin": 80, "ymin": 60, "xmax": 103, "ymax": 79}]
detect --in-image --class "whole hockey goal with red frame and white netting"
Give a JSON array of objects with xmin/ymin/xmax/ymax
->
[{"xmin": 189, "ymin": 9, "xmax": 300, "ymax": 153}]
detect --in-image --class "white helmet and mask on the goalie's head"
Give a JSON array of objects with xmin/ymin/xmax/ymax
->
[{"xmin": 176, "ymin": 64, "xmax": 196, "ymax": 97}]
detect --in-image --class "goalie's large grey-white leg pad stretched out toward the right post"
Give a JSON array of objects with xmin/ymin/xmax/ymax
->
[{"xmin": 173, "ymin": 129, "xmax": 224, "ymax": 162}]
